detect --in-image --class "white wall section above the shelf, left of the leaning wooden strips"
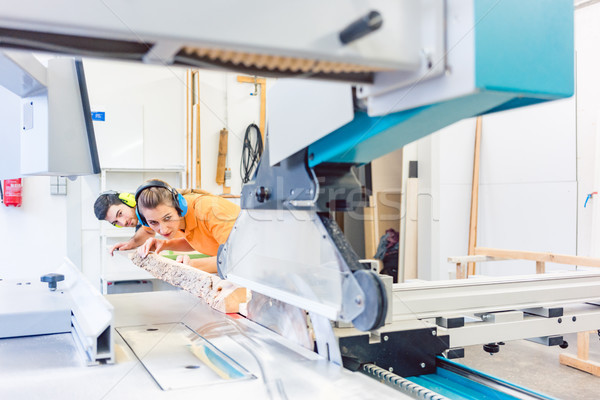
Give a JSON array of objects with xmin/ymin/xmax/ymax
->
[{"xmin": 84, "ymin": 60, "xmax": 185, "ymax": 171}]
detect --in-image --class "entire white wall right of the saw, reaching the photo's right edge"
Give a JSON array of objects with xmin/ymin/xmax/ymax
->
[{"xmin": 412, "ymin": 3, "xmax": 600, "ymax": 278}]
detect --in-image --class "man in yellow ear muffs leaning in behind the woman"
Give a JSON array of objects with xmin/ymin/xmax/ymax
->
[{"xmin": 94, "ymin": 190, "xmax": 154, "ymax": 255}]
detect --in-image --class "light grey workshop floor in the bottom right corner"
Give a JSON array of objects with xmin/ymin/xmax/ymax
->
[{"xmin": 455, "ymin": 334, "xmax": 600, "ymax": 400}]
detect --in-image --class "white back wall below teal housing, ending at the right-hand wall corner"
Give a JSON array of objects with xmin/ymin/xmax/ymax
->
[{"xmin": 417, "ymin": 98, "xmax": 577, "ymax": 279}]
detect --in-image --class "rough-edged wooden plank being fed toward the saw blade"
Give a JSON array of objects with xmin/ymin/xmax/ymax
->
[{"xmin": 129, "ymin": 252, "xmax": 246, "ymax": 313}]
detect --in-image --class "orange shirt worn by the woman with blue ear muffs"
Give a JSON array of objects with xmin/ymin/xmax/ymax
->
[{"xmin": 183, "ymin": 193, "xmax": 240, "ymax": 256}]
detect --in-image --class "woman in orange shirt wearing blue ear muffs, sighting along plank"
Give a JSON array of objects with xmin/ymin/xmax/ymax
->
[{"xmin": 135, "ymin": 179, "xmax": 240, "ymax": 273}]
